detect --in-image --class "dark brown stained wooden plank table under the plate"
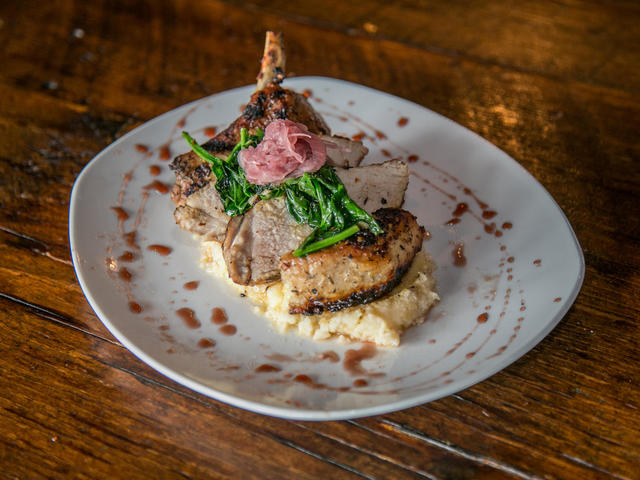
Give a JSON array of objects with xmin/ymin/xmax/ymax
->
[{"xmin": 0, "ymin": 0, "xmax": 640, "ymax": 479}]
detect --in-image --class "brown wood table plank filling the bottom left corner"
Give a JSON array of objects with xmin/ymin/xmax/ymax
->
[{"xmin": 0, "ymin": 299, "xmax": 411, "ymax": 478}]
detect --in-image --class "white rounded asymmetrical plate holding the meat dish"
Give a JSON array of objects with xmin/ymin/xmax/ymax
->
[{"xmin": 69, "ymin": 77, "xmax": 584, "ymax": 420}]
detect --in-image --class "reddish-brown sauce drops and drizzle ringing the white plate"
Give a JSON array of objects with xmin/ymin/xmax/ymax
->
[{"xmin": 99, "ymin": 92, "xmax": 541, "ymax": 400}]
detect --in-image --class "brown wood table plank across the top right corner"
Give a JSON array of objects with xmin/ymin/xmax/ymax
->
[{"xmin": 221, "ymin": 0, "xmax": 640, "ymax": 94}]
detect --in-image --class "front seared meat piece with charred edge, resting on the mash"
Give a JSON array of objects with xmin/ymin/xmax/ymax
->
[{"xmin": 280, "ymin": 208, "xmax": 424, "ymax": 315}]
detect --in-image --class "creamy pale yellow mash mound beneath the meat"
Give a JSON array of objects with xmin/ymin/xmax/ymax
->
[{"xmin": 200, "ymin": 242, "xmax": 440, "ymax": 347}]
